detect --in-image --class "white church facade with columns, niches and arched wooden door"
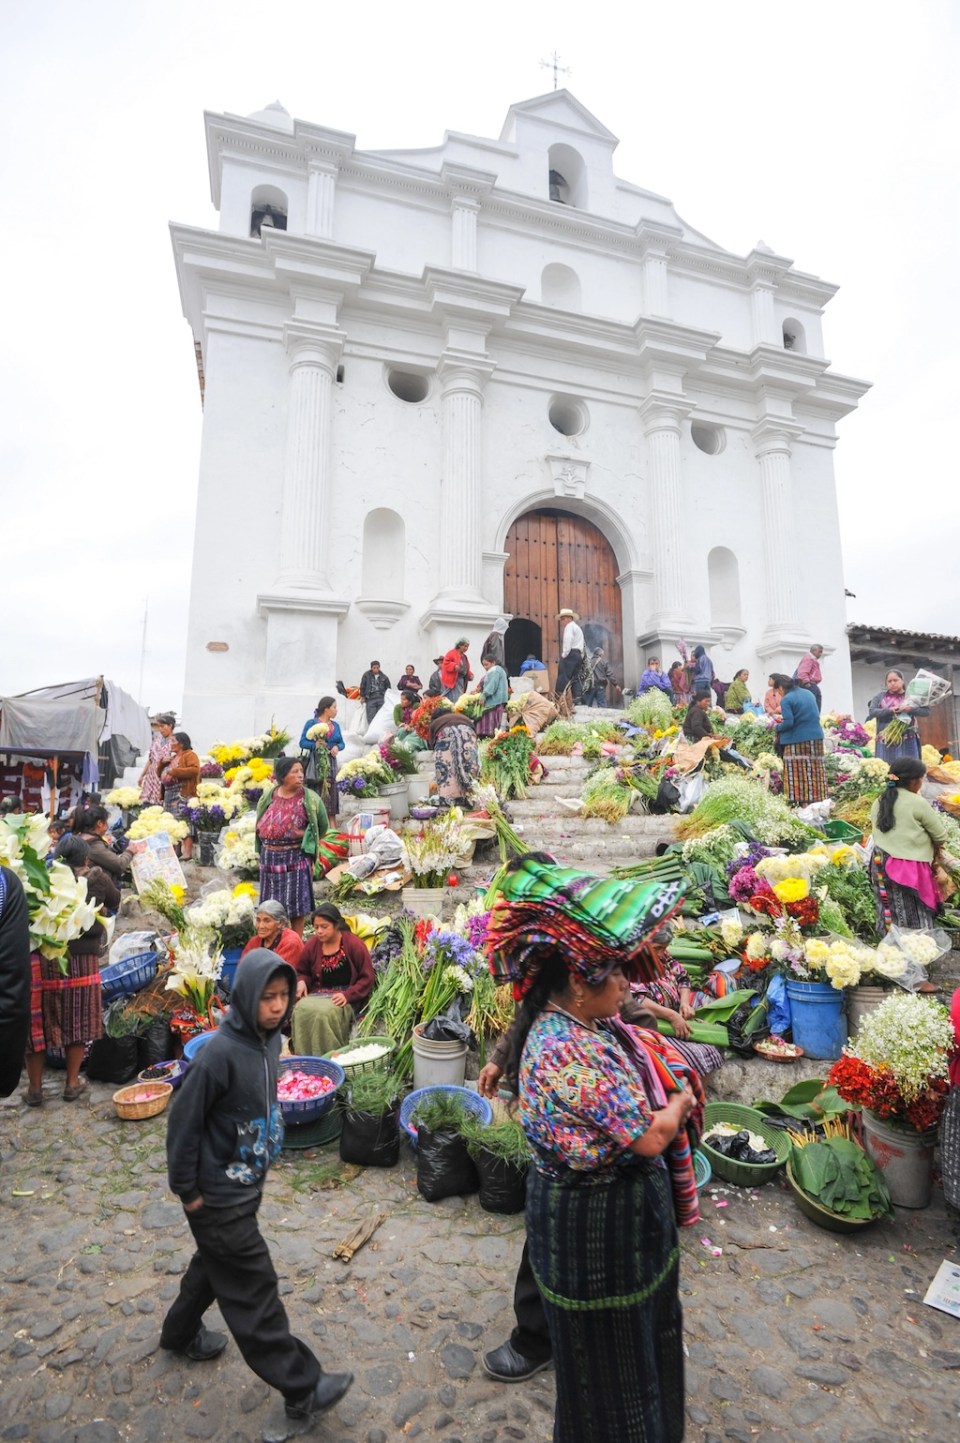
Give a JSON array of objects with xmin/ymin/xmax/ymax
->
[{"xmin": 172, "ymin": 89, "xmax": 868, "ymax": 746}]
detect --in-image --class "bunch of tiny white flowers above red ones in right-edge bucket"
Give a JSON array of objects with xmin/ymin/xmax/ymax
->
[{"xmin": 850, "ymin": 991, "xmax": 956, "ymax": 1102}]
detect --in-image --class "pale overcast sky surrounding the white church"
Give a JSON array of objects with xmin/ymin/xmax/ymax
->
[{"xmin": 0, "ymin": 0, "xmax": 960, "ymax": 724}]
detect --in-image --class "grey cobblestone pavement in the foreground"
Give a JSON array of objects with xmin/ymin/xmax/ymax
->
[{"xmin": 0, "ymin": 1074, "xmax": 960, "ymax": 1443}]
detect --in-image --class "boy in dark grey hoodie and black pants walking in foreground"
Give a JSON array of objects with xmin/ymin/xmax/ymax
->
[{"xmin": 160, "ymin": 948, "xmax": 354, "ymax": 1431}]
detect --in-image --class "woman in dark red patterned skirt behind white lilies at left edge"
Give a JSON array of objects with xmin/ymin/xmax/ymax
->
[{"xmin": 25, "ymin": 837, "xmax": 120, "ymax": 1107}]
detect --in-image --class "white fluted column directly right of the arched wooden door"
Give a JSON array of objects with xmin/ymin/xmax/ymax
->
[{"xmin": 641, "ymin": 403, "xmax": 687, "ymax": 626}]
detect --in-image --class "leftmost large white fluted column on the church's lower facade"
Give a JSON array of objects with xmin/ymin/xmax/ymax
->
[{"xmin": 279, "ymin": 332, "xmax": 342, "ymax": 592}]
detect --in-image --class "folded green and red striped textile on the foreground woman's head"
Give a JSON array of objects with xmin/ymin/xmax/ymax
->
[{"xmin": 486, "ymin": 857, "xmax": 683, "ymax": 1000}]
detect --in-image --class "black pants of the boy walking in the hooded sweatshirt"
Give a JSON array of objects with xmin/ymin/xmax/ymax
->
[{"xmin": 160, "ymin": 1202, "xmax": 322, "ymax": 1401}]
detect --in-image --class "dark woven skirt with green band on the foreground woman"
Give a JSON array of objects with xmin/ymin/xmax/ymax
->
[{"xmin": 527, "ymin": 1163, "xmax": 684, "ymax": 1443}]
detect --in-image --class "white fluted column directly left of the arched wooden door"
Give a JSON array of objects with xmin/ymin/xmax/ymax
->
[{"xmin": 439, "ymin": 361, "xmax": 489, "ymax": 602}]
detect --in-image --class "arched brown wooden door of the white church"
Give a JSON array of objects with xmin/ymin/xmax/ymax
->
[{"xmin": 504, "ymin": 511, "xmax": 624, "ymax": 684}]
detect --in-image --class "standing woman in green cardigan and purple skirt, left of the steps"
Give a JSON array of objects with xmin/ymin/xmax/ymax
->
[{"xmin": 257, "ymin": 756, "xmax": 328, "ymax": 937}]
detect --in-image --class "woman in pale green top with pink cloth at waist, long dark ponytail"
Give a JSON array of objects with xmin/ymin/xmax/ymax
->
[{"xmin": 870, "ymin": 756, "xmax": 948, "ymax": 932}]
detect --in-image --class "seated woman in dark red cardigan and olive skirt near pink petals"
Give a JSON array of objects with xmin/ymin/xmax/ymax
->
[{"xmin": 292, "ymin": 902, "xmax": 374, "ymax": 1058}]
